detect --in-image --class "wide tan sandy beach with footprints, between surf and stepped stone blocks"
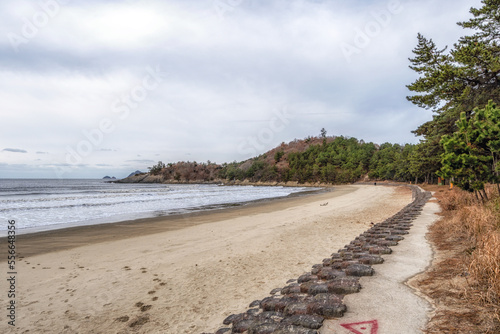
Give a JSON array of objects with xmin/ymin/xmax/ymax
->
[{"xmin": 0, "ymin": 185, "xmax": 411, "ymax": 334}]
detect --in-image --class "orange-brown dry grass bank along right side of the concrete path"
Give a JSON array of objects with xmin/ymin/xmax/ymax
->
[{"xmin": 418, "ymin": 186, "xmax": 500, "ymax": 333}]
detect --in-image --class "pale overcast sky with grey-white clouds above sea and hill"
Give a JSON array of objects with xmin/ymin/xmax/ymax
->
[{"xmin": 0, "ymin": 0, "xmax": 481, "ymax": 178}]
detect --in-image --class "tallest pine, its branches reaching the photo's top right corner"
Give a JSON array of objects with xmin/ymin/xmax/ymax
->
[{"xmin": 407, "ymin": 0, "xmax": 500, "ymax": 183}]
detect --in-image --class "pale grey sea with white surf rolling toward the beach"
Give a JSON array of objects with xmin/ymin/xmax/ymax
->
[{"xmin": 0, "ymin": 179, "xmax": 312, "ymax": 236}]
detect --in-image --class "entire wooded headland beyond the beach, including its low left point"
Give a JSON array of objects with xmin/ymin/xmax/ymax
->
[{"xmin": 123, "ymin": 135, "xmax": 432, "ymax": 184}]
